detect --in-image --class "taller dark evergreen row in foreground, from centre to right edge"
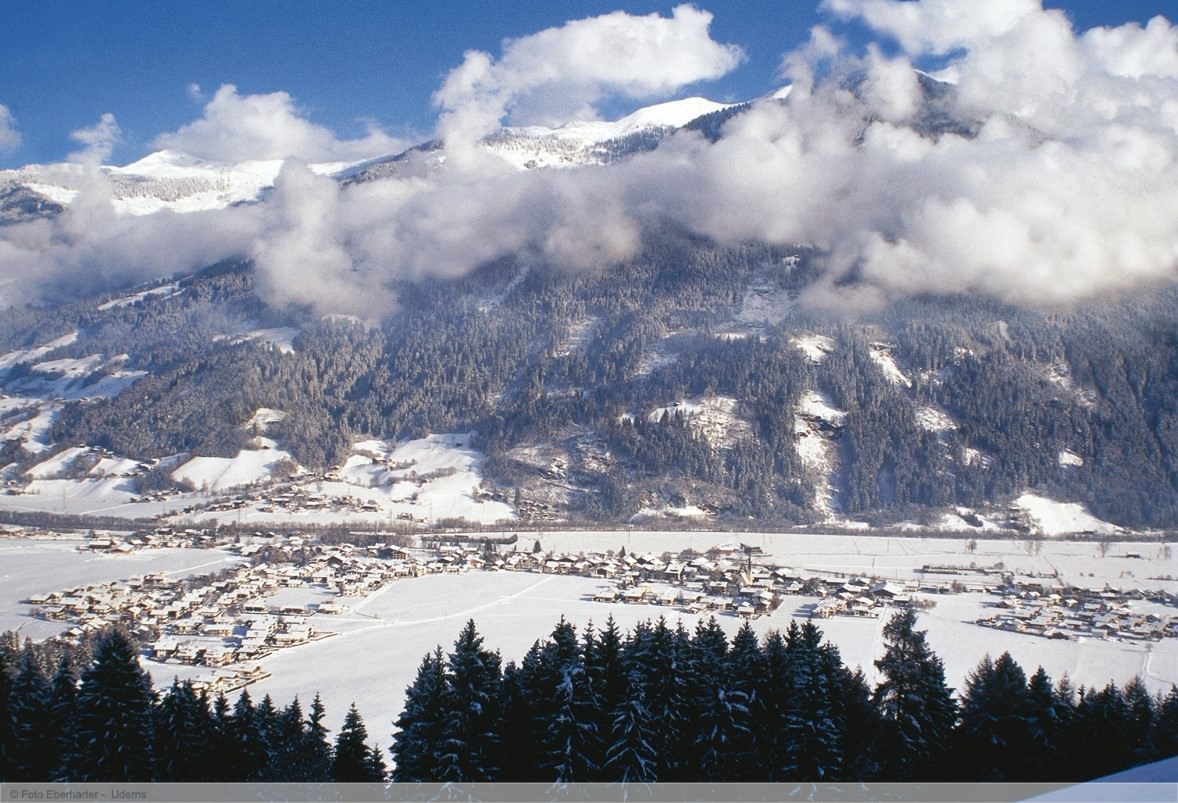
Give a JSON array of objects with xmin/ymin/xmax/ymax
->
[{"xmin": 391, "ymin": 610, "xmax": 1178, "ymax": 783}]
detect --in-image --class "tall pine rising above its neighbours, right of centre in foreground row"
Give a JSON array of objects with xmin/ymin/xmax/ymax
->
[{"xmin": 875, "ymin": 609, "xmax": 957, "ymax": 781}]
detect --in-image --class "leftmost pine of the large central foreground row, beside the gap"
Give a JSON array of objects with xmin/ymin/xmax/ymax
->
[{"xmin": 390, "ymin": 646, "xmax": 445, "ymax": 783}]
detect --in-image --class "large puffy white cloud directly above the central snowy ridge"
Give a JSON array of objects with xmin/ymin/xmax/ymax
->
[{"xmin": 434, "ymin": 6, "xmax": 743, "ymax": 157}]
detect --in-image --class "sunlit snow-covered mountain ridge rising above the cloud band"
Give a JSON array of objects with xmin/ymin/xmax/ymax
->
[{"xmin": 0, "ymin": 98, "xmax": 729, "ymax": 224}]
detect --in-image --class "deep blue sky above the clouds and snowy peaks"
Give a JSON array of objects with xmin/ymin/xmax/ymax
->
[{"xmin": 0, "ymin": 0, "xmax": 1174, "ymax": 167}]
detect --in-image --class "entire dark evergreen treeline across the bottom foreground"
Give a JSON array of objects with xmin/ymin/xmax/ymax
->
[{"xmin": 0, "ymin": 611, "xmax": 1178, "ymax": 783}]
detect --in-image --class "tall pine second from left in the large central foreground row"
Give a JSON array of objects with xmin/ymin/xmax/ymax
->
[{"xmin": 438, "ymin": 619, "xmax": 502, "ymax": 782}]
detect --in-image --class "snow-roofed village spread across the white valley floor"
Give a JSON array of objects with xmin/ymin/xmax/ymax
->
[{"xmin": 11, "ymin": 526, "xmax": 1178, "ymax": 692}]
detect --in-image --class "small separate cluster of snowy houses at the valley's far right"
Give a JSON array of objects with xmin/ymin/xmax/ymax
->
[{"xmin": 975, "ymin": 583, "xmax": 1178, "ymax": 642}]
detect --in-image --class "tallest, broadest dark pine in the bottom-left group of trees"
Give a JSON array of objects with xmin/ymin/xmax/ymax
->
[{"xmin": 70, "ymin": 631, "xmax": 154, "ymax": 782}]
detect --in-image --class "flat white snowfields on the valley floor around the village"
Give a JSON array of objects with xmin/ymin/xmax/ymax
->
[{"xmin": 0, "ymin": 525, "xmax": 1178, "ymax": 741}]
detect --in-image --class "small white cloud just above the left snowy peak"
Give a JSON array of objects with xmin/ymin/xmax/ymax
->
[{"xmin": 152, "ymin": 84, "xmax": 405, "ymax": 162}]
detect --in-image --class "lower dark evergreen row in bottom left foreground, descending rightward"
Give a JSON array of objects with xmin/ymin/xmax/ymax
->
[{"xmin": 0, "ymin": 630, "xmax": 386, "ymax": 782}]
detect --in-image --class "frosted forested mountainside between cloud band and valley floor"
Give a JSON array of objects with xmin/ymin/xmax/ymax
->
[{"xmin": 0, "ymin": 224, "xmax": 1178, "ymax": 527}]
